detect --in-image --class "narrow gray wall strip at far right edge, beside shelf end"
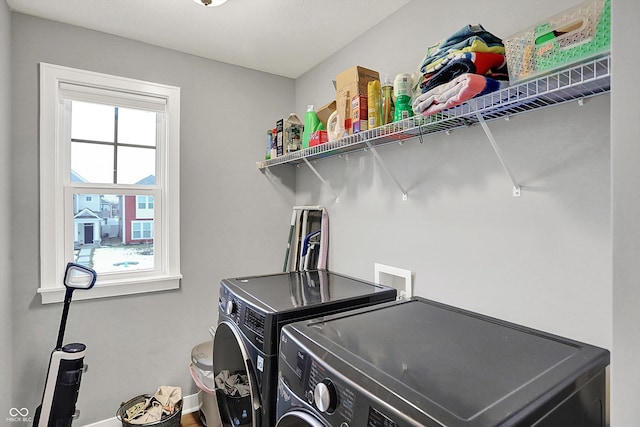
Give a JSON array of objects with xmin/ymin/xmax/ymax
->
[{"xmin": 611, "ymin": 1, "xmax": 640, "ymax": 426}]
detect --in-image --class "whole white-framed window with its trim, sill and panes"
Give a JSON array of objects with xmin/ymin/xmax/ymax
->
[{"xmin": 38, "ymin": 63, "xmax": 181, "ymax": 303}]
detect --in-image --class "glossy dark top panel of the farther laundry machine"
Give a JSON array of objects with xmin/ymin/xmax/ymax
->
[{"xmin": 222, "ymin": 270, "xmax": 396, "ymax": 313}]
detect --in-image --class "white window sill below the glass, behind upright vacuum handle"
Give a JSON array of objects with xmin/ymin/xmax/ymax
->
[{"xmin": 38, "ymin": 275, "xmax": 182, "ymax": 304}]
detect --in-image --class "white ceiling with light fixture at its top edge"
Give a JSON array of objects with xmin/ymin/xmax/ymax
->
[{"xmin": 7, "ymin": 0, "xmax": 410, "ymax": 78}]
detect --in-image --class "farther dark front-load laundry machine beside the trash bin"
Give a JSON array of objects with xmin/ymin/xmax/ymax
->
[{"xmin": 211, "ymin": 270, "xmax": 397, "ymax": 427}]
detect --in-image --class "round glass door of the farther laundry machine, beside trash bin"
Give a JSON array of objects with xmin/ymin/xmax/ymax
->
[{"xmin": 211, "ymin": 320, "xmax": 262, "ymax": 427}]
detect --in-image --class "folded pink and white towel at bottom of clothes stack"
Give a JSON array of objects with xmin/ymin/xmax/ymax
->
[{"xmin": 412, "ymin": 74, "xmax": 501, "ymax": 116}]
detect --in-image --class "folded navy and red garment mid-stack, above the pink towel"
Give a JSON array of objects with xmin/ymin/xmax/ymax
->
[{"xmin": 420, "ymin": 52, "xmax": 507, "ymax": 93}]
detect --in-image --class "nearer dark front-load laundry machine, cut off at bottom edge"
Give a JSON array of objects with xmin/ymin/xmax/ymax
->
[{"xmin": 276, "ymin": 297, "xmax": 609, "ymax": 427}]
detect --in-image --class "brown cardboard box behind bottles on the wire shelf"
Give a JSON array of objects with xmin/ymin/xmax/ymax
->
[{"xmin": 336, "ymin": 66, "xmax": 380, "ymax": 134}]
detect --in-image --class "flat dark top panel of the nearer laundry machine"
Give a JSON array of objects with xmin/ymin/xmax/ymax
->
[{"xmin": 283, "ymin": 298, "xmax": 609, "ymax": 426}]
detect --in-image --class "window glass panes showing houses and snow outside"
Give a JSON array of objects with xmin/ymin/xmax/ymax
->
[{"xmin": 70, "ymin": 101, "xmax": 157, "ymax": 273}]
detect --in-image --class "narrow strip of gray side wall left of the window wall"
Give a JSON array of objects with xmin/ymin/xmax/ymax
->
[{"xmin": 0, "ymin": 2, "xmax": 14, "ymax": 424}]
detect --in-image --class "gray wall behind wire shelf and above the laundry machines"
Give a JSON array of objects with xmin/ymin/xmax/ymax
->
[{"xmin": 296, "ymin": 0, "xmax": 612, "ymax": 360}]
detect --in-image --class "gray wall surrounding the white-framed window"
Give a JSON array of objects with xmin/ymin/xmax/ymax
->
[{"xmin": 10, "ymin": 12, "xmax": 294, "ymax": 425}]
